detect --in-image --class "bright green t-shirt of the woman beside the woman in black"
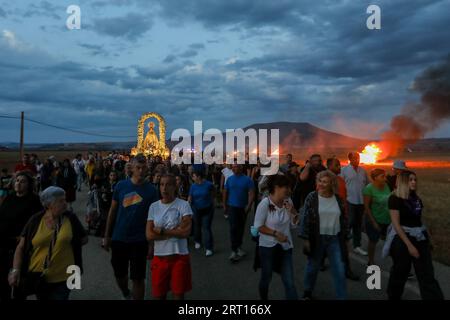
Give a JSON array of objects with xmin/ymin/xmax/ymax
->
[{"xmin": 363, "ymin": 183, "xmax": 391, "ymax": 224}]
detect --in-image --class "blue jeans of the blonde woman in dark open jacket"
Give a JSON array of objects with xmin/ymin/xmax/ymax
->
[{"xmin": 305, "ymin": 235, "xmax": 347, "ymax": 300}]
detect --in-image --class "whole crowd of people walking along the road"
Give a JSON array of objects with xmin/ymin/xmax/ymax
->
[{"xmin": 0, "ymin": 152, "xmax": 443, "ymax": 300}]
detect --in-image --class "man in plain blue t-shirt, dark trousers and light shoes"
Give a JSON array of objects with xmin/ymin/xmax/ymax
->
[{"xmin": 223, "ymin": 164, "xmax": 255, "ymax": 262}]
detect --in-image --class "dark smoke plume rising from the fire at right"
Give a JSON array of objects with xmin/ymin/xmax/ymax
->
[{"xmin": 381, "ymin": 55, "xmax": 450, "ymax": 156}]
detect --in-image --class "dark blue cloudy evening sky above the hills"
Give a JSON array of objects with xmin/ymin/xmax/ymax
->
[{"xmin": 0, "ymin": 0, "xmax": 450, "ymax": 142}]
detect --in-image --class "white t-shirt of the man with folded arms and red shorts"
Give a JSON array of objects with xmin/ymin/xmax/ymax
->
[{"xmin": 147, "ymin": 198, "xmax": 192, "ymax": 256}]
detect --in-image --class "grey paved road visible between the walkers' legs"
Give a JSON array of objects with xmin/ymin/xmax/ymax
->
[{"xmin": 71, "ymin": 192, "xmax": 450, "ymax": 300}]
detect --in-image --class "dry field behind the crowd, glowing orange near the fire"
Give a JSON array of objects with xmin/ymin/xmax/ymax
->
[{"xmin": 0, "ymin": 151, "xmax": 450, "ymax": 265}]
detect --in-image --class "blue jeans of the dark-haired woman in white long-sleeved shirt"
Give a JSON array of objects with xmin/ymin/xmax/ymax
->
[{"xmin": 259, "ymin": 245, "xmax": 298, "ymax": 300}]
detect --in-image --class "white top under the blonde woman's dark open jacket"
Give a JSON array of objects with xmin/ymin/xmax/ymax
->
[{"xmin": 319, "ymin": 195, "xmax": 341, "ymax": 236}]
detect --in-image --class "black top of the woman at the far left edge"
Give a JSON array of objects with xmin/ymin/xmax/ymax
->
[{"xmin": 0, "ymin": 194, "xmax": 42, "ymax": 246}]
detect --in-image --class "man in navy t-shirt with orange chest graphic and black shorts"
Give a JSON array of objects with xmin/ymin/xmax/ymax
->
[{"xmin": 104, "ymin": 155, "xmax": 159, "ymax": 300}]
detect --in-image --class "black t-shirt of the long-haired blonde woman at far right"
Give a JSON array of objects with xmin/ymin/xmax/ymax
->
[{"xmin": 388, "ymin": 194, "xmax": 423, "ymax": 228}]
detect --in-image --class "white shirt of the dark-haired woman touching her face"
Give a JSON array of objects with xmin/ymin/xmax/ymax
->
[{"xmin": 253, "ymin": 197, "xmax": 297, "ymax": 250}]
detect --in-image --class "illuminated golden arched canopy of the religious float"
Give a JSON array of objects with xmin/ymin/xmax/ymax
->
[{"xmin": 131, "ymin": 112, "xmax": 170, "ymax": 159}]
